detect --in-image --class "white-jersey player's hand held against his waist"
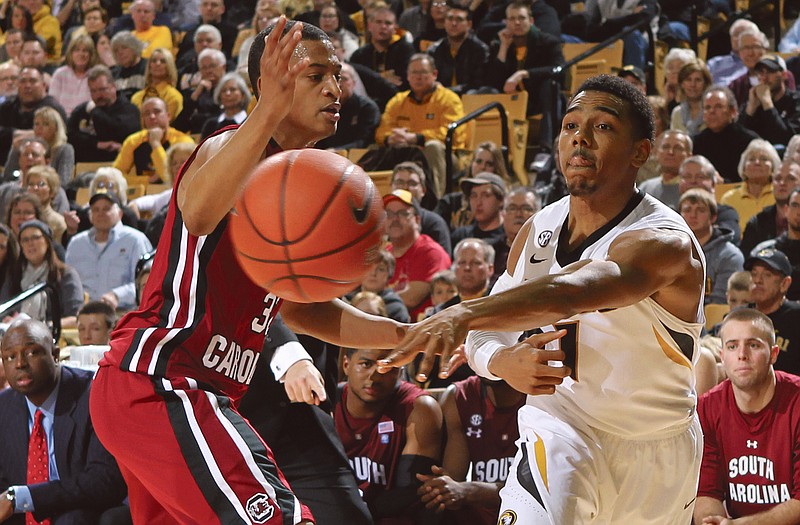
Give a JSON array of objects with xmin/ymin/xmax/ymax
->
[{"xmin": 488, "ymin": 330, "xmax": 572, "ymax": 396}]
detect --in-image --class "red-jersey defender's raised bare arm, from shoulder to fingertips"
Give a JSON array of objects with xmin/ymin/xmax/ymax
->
[{"xmin": 178, "ymin": 16, "xmax": 308, "ymax": 235}]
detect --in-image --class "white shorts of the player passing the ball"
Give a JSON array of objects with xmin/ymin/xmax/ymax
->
[{"xmin": 498, "ymin": 405, "xmax": 703, "ymax": 525}]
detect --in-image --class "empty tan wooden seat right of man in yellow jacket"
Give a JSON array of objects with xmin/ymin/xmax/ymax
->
[{"xmin": 461, "ymin": 91, "xmax": 528, "ymax": 184}]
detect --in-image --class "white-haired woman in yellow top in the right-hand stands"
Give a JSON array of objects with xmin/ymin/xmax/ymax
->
[{"xmin": 719, "ymin": 139, "xmax": 781, "ymax": 231}]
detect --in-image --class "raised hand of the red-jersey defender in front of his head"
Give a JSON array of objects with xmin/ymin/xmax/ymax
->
[{"xmin": 259, "ymin": 15, "xmax": 310, "ymax": 120}]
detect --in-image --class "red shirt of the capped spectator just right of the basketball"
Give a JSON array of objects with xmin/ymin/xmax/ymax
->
[{"xmin": 387, "ymin": 233, "xmax": 451, "ymax": 321}]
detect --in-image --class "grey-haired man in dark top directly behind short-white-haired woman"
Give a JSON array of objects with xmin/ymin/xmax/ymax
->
[{"xmin": 173, "ymin": 49, "xmax": 225, "ymax": 134}]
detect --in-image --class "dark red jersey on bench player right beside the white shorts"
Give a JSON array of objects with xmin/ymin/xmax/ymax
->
[{"xmin": 453, "ymin": 376, "xmax": 525, "ymax": 525}]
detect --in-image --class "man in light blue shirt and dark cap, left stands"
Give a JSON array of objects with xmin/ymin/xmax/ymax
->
[{"xmin": 66, "ymin": 192, "xmax": 153, "ymax": 309}]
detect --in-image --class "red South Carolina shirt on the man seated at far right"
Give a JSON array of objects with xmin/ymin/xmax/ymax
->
[{"xmin": 697, "ymin": 371, "xmax": 800, "ymax": 518}]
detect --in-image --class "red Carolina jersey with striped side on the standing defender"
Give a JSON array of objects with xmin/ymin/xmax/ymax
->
[{"xmin": 100, "ymin": 135, "xmax": 281, "ymax": 402}]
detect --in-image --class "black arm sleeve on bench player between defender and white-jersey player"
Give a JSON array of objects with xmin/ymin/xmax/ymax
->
[{"xmin": 369, "ymin": 454, "xmax": 439, "ymax": 525}]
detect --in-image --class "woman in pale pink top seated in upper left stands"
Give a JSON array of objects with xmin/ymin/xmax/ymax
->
[{"xmin": 50, "ymin": 35, "xmax": 99, "ymax": 115}]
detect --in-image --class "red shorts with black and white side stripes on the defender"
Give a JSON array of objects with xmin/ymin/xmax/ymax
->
[{"xmin": 90, "ymin": 367, "xmax": 313, "ymax": 525}]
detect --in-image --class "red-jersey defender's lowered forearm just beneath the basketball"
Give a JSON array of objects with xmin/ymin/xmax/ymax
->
[{"xmin": 281, "ymin": 299, "xmax": 409, "ymax": 349}]
